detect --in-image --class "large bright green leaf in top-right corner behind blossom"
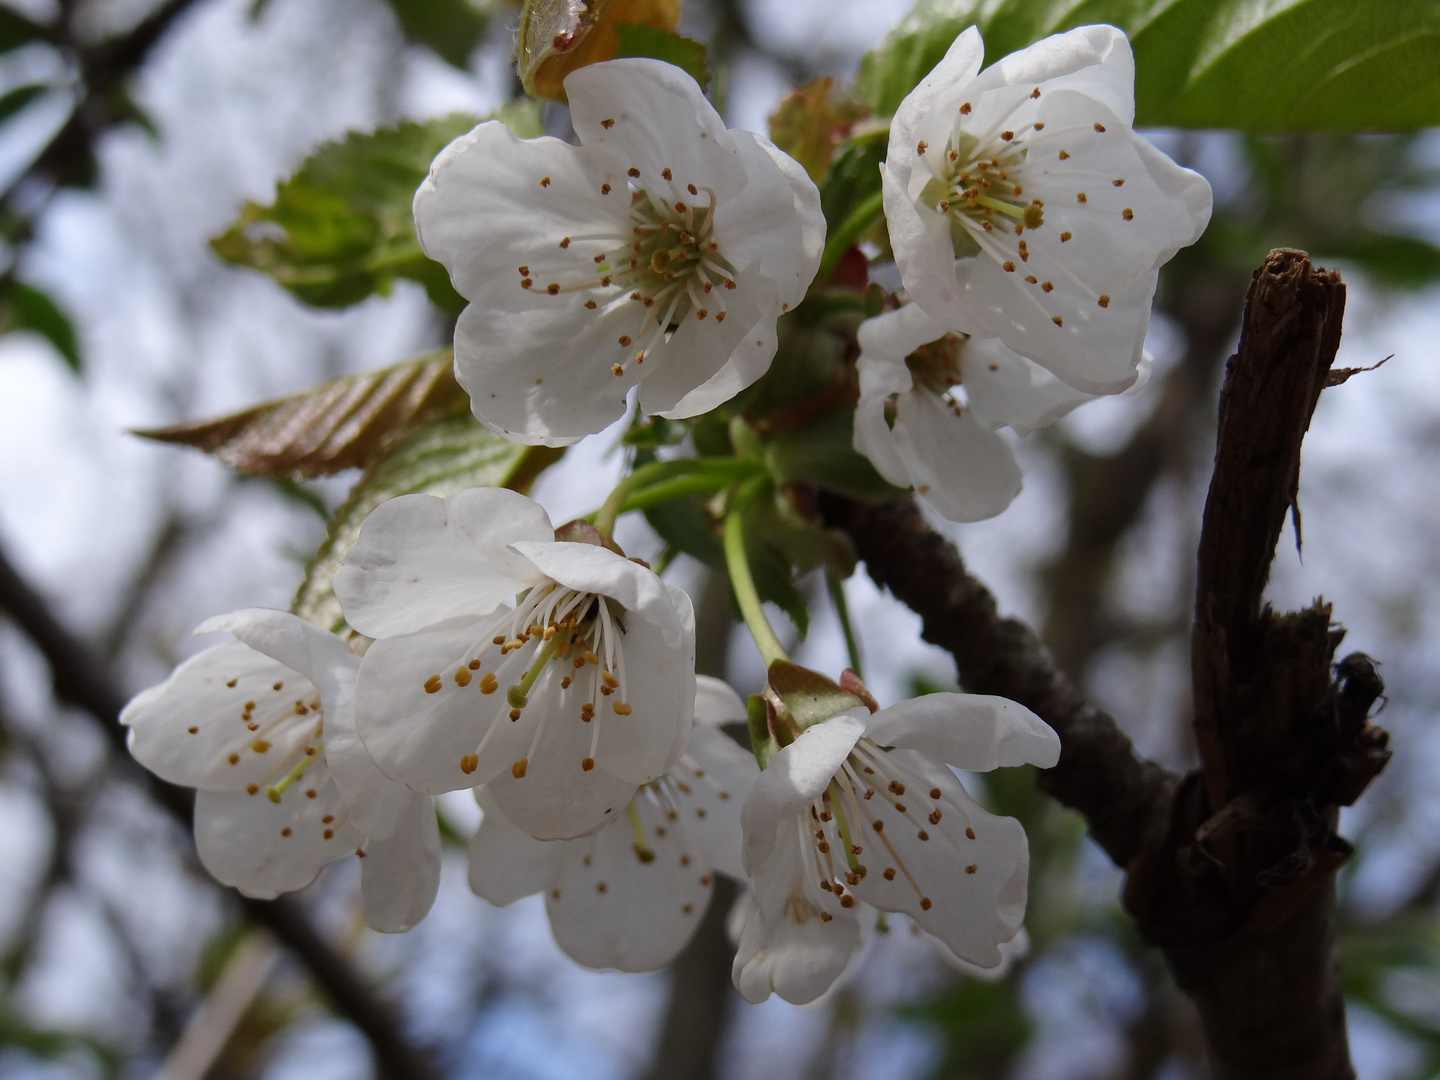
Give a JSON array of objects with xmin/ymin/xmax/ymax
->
[{"xmin": 858, "ymin": 0, "xmax": 1440, "ymax": 131}]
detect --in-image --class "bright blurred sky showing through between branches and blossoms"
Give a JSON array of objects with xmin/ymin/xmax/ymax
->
[{"xmin": 0, "ymin": 0, "xmax": 1440, "ymax": 1080}]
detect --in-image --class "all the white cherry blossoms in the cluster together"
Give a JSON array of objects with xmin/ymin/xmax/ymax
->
[{"xmin": 121, "ymin": 27, "xmax": 1208, "ymax": 1002}]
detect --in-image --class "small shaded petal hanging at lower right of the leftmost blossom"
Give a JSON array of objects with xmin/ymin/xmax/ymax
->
[{"xmin": 360, "ymin": 792, "xmax": 441, "ymax": 933}]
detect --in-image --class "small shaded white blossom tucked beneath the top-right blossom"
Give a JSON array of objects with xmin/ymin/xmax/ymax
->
[{"xmin": 855, "ymin": 304, "xmax": 1092, "ymax": 521}]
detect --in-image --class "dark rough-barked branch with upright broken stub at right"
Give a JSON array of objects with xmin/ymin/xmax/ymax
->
[{"xmin": 821, "ymin": 249, "xmax": 1390, "ymax": 1080}]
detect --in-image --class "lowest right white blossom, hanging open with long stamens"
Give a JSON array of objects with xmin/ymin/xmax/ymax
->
[{"xmin": 733, "ymin": 694, "xmax": 1060, "ymax": 1004}]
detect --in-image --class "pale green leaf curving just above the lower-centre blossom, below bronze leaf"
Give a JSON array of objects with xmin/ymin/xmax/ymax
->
[{"xmin": 291, "ymin": 413, "xmax": 564, "ymax": 632}]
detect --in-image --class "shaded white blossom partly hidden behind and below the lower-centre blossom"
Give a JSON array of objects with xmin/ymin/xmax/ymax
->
[{"xmin": 469, "ymin": 677, "xmax": 759, "ymax": 972}]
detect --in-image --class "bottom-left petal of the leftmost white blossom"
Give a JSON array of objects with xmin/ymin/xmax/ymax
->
[{"xmin": 194, "ymin": 762, "xmax": 360, "ymax": 900}]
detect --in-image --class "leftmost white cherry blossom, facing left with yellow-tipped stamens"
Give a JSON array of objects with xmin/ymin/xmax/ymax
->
[{"xmin": 120, "ymin": 608, "xmax": 439, "ymax": 932}]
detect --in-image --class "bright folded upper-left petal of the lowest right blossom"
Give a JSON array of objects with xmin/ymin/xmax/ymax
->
[{"xmin": 740, "ymin": 708, "xmax": 868, "ymax": 878}]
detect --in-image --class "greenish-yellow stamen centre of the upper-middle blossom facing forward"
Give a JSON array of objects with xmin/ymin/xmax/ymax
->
[{"xmin": 518, "ymin": 168, "xmax": 736, "ymax": 376}]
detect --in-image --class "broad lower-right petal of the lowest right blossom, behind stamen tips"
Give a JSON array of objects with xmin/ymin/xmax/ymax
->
[{"xmin": 852, "ymin": 750, "xmax": 1030, "ymax": 968}]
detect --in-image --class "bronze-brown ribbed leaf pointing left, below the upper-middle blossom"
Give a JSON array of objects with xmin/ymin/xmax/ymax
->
[{"xmin": 135, "ymin": 348, "xmax": 469, "ymax": 478}]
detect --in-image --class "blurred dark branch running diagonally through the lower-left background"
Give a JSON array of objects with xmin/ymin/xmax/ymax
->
[{"xmin": 0, "ymin": 541, "xmax": 435, "ymax": 1080}]
